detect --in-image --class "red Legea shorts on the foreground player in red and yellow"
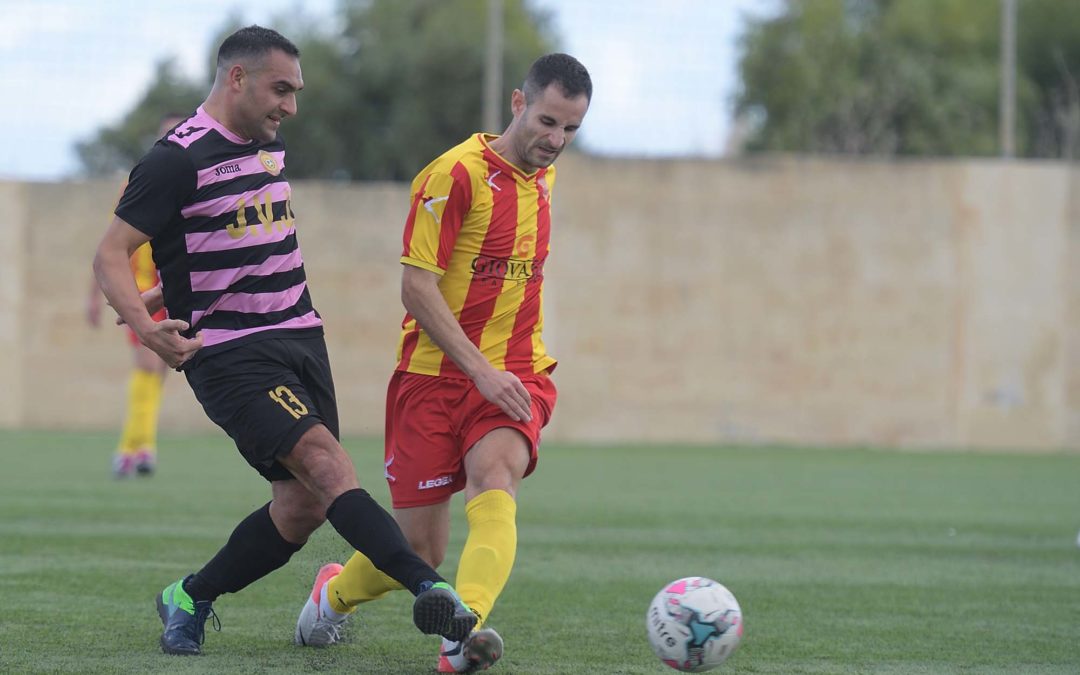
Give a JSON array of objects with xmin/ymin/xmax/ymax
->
[{"xmin": 384, "ymin": 370, "xmax": 557, "ymax": 509}]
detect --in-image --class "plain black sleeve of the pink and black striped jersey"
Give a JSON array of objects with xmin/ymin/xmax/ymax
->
[{"xmin": 116, "ymin": 143, "xmax": 195, "ymax": 239}]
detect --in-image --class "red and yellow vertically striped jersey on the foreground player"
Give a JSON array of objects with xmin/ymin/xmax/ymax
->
[{"xmin": 397, "ymin": 134, "xmax": 555, "ymax": 377}]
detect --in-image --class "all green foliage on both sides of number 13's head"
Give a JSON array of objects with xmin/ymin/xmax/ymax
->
[{"xmin": 78, "ymin": 0, "xmax": 556, "ymax": 180}]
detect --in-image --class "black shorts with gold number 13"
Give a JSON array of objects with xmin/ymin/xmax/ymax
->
[{"xmin": 185, "ymin": 335, "xmax": 339, "ymax": 481}]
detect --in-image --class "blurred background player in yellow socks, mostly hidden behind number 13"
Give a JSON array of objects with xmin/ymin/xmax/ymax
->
[{"xmin": 86, "ymin": 114, "xmax": 184, "ymax": 478}]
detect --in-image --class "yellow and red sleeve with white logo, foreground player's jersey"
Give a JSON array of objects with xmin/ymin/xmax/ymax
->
[{"xmin": 401, "ymin": 168, "xmax": 471, "ymax": 275}]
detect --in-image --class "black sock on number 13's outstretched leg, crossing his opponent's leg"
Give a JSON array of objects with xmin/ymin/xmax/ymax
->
[{"xmin": 326, "ymin": 487, "xmax": 445, "ymax": 595}]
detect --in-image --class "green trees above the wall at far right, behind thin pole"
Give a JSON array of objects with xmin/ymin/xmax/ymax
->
[{"xmin": 735, "ymin": 0, "xmax": 1080, "ymax": 159}]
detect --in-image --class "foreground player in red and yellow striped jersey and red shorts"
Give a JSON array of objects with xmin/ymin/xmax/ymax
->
[{"xmin": 297, "ymin": 54, "xmax": 592, "ymax": 672}]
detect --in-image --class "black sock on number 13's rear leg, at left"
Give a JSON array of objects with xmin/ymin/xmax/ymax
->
[{"xmin": 184, "ymin": 502, "xmax": 303, "ymax": 602}]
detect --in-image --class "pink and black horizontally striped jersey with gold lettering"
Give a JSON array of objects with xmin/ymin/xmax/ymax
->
[{"xmin": 116, "ymin": 108, "xmax": 322, "ymax": 365}]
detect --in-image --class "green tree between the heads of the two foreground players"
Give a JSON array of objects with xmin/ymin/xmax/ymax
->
[{"xmin": 287, "ymin": 0, "xmax": 554, "ymax": 180}]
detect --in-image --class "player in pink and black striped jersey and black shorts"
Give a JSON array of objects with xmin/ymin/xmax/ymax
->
[{"xmin": 94, "ymin": 26, "xmax": 476, "ymax": 654}]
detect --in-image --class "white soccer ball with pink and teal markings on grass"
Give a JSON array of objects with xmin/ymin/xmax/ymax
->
[{"xmin": 645, "ymin": 577, "xmax": 743, "ymax": 673}]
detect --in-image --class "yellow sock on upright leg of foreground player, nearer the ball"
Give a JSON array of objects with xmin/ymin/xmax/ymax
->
[{"xmin": 457, "ymin": 490, "xmax": 517, "ymax": 627}]
